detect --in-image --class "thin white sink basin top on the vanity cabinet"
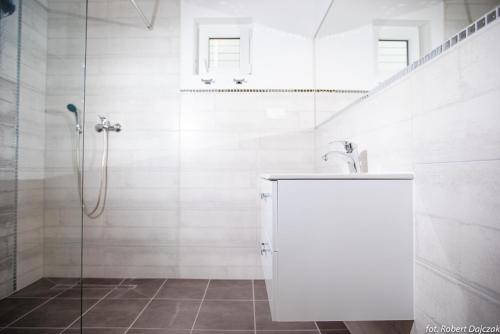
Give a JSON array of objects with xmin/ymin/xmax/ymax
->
[{"xmin": 261, "ymin": 173, "xmax": 413, "ymax": 181}]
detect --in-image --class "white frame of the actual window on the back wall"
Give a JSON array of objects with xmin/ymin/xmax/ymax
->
[{"xmin": 197, "ymin": 23, "xmax": 252, "ymax": 78}]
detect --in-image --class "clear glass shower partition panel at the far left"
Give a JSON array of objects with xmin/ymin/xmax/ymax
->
[{"xmin": 0, "ymin": 0, "xmax": 88, "ymax": 330}]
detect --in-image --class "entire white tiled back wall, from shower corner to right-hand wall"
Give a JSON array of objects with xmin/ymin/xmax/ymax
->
[{"xmin": 45, "ymin": 0, "xmax": 314, "ymax": 278}]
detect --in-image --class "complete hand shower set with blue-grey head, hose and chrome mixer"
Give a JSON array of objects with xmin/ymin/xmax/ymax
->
[{"xmin": 66, "ymin": 104, "xmax": 121, "ymax": 219}]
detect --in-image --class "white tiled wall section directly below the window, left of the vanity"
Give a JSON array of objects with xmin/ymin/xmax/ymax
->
[{"xmin": 178, "ymin": 93, "xmax": 314, "ymax": 278}]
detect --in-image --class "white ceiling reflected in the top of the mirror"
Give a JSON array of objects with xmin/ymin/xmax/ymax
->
[{"xmin": 318, "ymin": 0, "xmax": 442, "ymax": 36}]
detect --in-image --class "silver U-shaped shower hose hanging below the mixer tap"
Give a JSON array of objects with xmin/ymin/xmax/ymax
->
[{"xmin": 74, "ymin": 129, "xmax": 109, "ymax": 219}]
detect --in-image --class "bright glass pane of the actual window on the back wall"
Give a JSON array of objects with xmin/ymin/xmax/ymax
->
[{"xmin": 208, "ymin": 38, "xmax": 240, "ymax": 71}]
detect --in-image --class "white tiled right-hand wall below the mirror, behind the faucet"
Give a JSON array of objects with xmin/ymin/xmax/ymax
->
[{"xmin": 316, "ymin": 23, "xmax": 500, "ymax": 333}]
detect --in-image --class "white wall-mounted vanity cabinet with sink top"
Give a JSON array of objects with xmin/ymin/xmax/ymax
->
[{"xmin": 261, "ymin": 174, "xmax": 413, "ymax": 321}]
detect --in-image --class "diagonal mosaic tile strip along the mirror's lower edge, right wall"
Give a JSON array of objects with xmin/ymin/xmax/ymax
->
[{"xmin": 364, "ymin": 6, "xmax": 500, "ymax": 99}]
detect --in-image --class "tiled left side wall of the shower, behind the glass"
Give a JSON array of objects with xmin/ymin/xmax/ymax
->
[{"xmin": 0, "ymin": 1, "xmax": 47, "ymax": 296}]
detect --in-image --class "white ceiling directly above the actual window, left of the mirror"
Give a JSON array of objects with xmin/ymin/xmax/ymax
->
[{"xmin": 184, "ymin": 0, "xmax": 331, "ymax": 37}]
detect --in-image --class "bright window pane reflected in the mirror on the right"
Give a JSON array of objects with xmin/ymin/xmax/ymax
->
[{"xmin": 378, "ymin": 39, "xmax": 410, "ymax": 78}]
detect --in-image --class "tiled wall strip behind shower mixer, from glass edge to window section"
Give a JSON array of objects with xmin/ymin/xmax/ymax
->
[{"xmin": 79, "ymin": 0, "xmax": 184, "ymax": 277}]
